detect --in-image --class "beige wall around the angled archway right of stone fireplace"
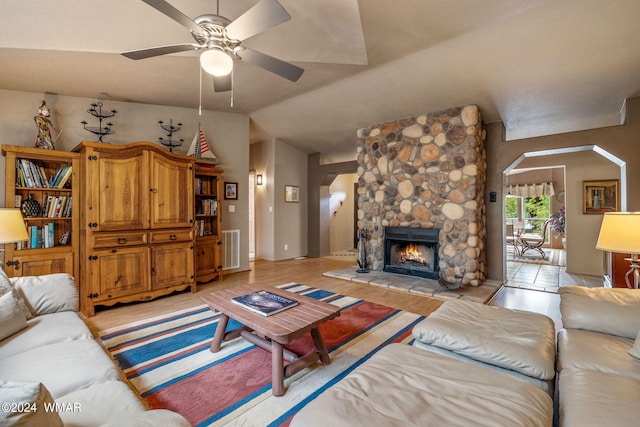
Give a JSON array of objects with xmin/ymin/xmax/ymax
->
[{"xmin": 485, "ymin": 98, "xmax": 640, "ymax": 280}]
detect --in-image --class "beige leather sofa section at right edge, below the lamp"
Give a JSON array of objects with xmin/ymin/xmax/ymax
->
[{"xmin": 557, "ymin": 286, "xmax": 640, "ymax": 427}]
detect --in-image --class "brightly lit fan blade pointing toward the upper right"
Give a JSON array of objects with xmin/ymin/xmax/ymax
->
[{"xmin": 225, "ymin": 0, "xmax": 291, "ymax": 41}]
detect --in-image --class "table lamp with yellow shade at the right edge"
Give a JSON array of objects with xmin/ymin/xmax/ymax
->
[{"xmin": 596, "ymin": 212, "xmax": 640, "ymax": 289}]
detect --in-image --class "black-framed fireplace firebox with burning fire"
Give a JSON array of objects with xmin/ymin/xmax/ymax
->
[{"xmin": 383, "ymin": 227, "xmax": 440, "ymax": 279}]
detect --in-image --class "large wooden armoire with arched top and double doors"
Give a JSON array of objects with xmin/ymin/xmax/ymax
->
[{"xmin": 73, "ymin": 142, "xmax": 196, "ymax": 316}]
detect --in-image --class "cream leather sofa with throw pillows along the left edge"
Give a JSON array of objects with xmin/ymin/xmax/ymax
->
[{"xmin": 0, "ymin": 272, "xmax": 191, "ymax": 427}]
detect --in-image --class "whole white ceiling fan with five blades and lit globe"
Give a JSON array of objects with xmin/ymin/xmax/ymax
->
[{"xmin": 122, "ymin": 0, "xmax": 304, "ymax": 92}]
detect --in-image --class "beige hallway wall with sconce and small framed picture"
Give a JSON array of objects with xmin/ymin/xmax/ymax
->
[{"xmin": 250, "ymin": 140, "xmax": 308, "ymax": 261}]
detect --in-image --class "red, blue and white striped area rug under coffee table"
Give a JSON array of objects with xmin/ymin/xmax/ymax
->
[{"xmin": 100, "ymin": 283, "xmax": 424, "ymax": 427}]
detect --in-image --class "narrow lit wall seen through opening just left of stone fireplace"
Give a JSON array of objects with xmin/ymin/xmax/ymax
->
[{"xmin": 329, "ymin": 173, "xmax": 358, "ymax": 253}]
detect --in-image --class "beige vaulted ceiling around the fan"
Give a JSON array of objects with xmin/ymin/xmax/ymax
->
[{"xmin": 0, "ymin": 0, "xmax": 640, "ymax": 161}]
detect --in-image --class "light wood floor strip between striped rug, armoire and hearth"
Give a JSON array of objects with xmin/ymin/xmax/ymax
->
[{"xmin": 85, "ymin": 258, "xmax": 442, "ymax": 334}]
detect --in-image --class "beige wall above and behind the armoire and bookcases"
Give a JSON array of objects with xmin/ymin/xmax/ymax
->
[{"xmin": 0, "ymin": 90, "xmax": 249, "ymax": 273}]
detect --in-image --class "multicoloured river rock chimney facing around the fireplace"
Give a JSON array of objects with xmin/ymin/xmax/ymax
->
[{"xmin": 358, "ymin": 105, "xmax": 486, "ymax": 286}]
